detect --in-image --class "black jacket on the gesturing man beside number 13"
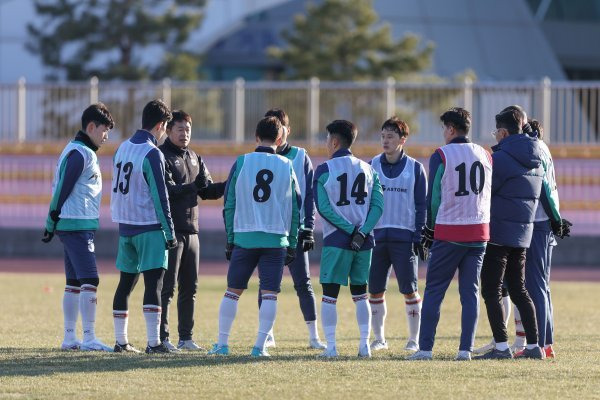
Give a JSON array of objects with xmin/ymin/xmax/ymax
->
[{"xmin": 159, "ymin": 138, "xmax": 225, "ymax": 233}]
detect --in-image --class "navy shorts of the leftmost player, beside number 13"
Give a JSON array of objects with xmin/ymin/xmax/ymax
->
[{"xmin": 56, "ymin": 231, "xmax": 98, "ymax": 280}]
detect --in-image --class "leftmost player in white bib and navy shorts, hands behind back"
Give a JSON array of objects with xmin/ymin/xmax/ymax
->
[{"xmin": 42, "ymin": 103, "xmax": 114, "ymax": 351}]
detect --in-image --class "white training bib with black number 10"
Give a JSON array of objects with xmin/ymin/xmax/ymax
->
[{"xmin": 435, "ymin": 143, "xmax": 492, "ymax": 225}]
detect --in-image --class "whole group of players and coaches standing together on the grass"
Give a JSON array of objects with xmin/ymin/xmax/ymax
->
[{"xmin": 42, "ymin": 100, "xmax": 570, "ymax": 360}]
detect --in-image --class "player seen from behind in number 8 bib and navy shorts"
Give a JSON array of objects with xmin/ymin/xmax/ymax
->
[{"xmin": 209, "ymin": 117, "xmax": 301, "ymax": 357}]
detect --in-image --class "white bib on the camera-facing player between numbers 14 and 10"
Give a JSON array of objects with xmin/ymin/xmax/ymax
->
[{"xmin": 371, "ymin": 154, "xmax": 416, "ymax": 232}]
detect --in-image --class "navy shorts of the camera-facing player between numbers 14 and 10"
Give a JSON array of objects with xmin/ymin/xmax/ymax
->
[{"xmin": 369, "ymin": 242, "xmax": 418, "ymax": 294}]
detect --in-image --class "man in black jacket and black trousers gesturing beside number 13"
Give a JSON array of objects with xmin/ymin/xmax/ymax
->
[{"xmin": 159, "ymin": 111, "xmax": 225, "ymax": 350}]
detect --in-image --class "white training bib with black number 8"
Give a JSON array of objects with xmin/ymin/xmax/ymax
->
[{"xmin": 233, "ymin": 152, "xmax": 298, "ymax": 236}]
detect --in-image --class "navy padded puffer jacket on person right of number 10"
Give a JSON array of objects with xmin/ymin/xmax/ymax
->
[{"xmin": 490, "ymin": 134, "xmax": 544, "ymax": 248}]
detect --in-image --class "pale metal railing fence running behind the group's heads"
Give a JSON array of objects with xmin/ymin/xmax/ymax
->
[{"xmin": 0, "ymin": 78, "xmax": 600, "ymax": 145}]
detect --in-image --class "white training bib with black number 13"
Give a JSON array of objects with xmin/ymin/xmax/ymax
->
[{"xmin": 110, "ymin": 140, "xmax": 164, "ymax": 225}]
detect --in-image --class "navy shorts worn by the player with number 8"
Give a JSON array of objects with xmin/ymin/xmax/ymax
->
[{"xmin": 227, "ymin": 246, "xmax": 286, "ymax": 293}]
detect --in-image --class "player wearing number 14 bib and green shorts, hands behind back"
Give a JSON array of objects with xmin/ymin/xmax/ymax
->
[{"xmin": 313, "ymin": 120, "xmax": 383, "ymax": 358}]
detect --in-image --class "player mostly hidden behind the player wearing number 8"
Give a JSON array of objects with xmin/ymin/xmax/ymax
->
[{"xmin": 258, "ymin": 108, "xmax": 325, "ymax": 350}]
